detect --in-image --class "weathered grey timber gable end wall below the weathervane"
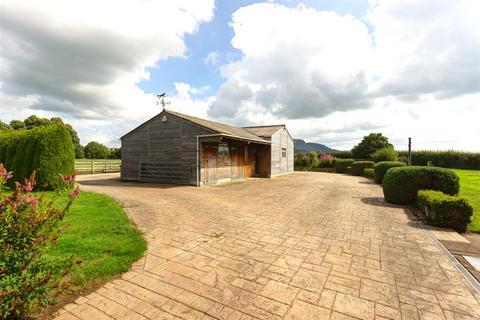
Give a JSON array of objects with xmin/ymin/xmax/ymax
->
[{"xmin": 122, "ymin": 113, "xmax": 212, "ymax": 184}]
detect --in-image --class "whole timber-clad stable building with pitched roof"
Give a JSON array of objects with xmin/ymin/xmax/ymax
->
[{"xmin": 121, "ymin": 110, "xmax": 293, "ymax": 186}]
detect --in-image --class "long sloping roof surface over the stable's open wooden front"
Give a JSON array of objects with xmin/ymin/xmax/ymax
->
[{"xmin": 165, "ymin": 110, "xmax": 268, "ymax": 143}]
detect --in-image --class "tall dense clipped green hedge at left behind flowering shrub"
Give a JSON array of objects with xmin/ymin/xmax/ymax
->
[{"xmin": 0, "ymin": 124, "xmax": 75, "ymax": 190}]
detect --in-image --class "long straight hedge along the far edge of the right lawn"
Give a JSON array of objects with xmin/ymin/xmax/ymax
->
[{"xmin": 398, "ymin": 150, "xmax": 480, "ymax": 170}]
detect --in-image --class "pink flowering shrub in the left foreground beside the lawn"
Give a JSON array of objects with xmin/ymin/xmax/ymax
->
[{"xmin": 0, "ymin": 164, "xmax": 80, "ymax": 319}]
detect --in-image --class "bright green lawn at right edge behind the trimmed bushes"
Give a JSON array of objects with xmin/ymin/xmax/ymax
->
[{"xmin": 455, "ymin": 169, "xmax": 480, "ymax": 233}]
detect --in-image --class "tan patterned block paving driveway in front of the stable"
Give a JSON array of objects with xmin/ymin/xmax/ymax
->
[{"xmin": 58, "ymin": 173, "xmax": 480, "ymax": 320}]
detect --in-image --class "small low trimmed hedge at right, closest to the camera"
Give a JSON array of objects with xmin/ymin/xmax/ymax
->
[{"xmin": 417, "ymin": 190, "xmax": 473, "ymax": 232}]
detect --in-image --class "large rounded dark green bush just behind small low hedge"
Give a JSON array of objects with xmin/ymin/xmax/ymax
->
[{"xmin": 383, "ymin": 166, "xmax": 460, "ymax": 204}]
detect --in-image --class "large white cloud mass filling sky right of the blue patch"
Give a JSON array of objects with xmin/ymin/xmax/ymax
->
[{"xmin": 209, "ymin": 0, "xmax": 480, "ymax": 150}]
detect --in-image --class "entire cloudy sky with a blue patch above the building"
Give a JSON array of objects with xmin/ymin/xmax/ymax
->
[{"xmin": 0, "ymin": 0, "xmax": 480, "ymax": 151}]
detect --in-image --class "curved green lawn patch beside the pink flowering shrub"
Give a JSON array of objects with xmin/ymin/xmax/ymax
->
[{"xmin": 49, "ymin": 191, "xmax": 146, "ymax": 287}]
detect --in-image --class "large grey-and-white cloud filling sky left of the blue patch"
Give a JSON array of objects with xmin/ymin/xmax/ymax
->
[{"xmin": 0, "ymin": 0, "xmax": 214, "ymax": 120}]
